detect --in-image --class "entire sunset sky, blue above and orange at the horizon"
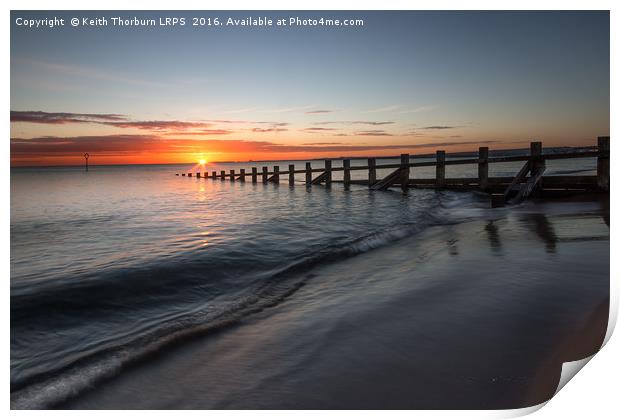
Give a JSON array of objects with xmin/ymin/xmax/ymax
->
[{"xmin": 11, "ymin": 11, "xmax": 610, "ymax": 166}]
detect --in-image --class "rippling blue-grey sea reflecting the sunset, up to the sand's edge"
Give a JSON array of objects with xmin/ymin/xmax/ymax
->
[{"xmin": 11, "ymin": 154, "xmax": 595, "ymax": 407}]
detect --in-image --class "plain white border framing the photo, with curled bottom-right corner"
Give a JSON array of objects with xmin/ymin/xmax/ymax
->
[{"xmin": 0, "ymin": 0, "xmax": 620, "ymax": 420}]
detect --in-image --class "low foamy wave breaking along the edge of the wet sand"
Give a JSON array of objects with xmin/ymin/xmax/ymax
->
[{"xmin": 11, "ymin": 208, "xmax": 452, "ymax": 409}]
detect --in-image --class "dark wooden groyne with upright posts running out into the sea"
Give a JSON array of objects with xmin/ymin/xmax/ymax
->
[{"xmin": 176, "ymin": 137, "xmax": 609, "ymax": 207}]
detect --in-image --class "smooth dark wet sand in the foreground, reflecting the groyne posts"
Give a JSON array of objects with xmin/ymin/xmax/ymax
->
[{"xmin": 59, "ymin": 203, "xmax": 609, "ymax": 409}]
